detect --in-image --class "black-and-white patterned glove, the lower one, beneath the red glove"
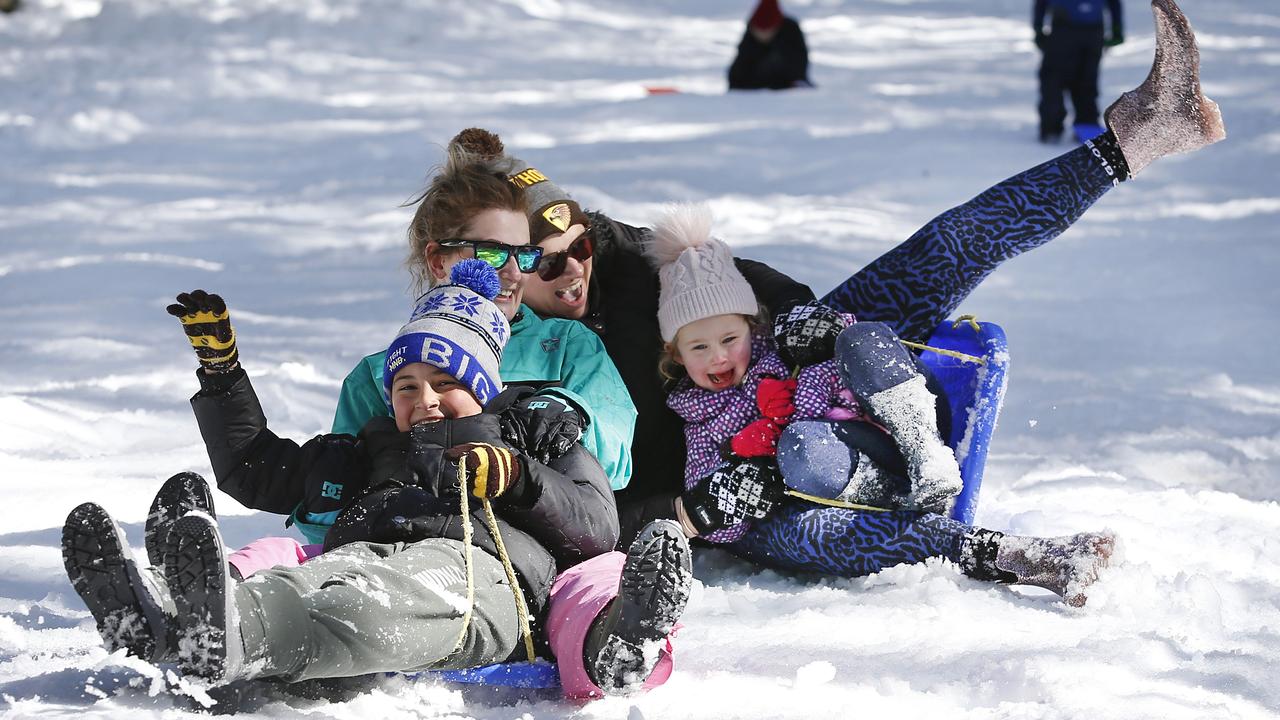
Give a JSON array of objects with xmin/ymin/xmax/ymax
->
[{"xmin": 681, "ymin": 457, "xmax": 782, "ymax": 536}]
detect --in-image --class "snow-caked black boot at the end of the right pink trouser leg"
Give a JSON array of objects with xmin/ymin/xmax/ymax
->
[{"xmin": 582, "ymin": 520, "xmax": 694, "ymax": 694}]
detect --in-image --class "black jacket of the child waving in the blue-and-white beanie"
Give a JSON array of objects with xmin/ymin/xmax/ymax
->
[{"xmin": 191, "ymin": 370, "xmax": 618, "ymax": 614}]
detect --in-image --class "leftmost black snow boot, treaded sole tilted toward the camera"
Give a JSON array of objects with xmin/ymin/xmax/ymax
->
[{"xmin": 63, "ymin": 502, "xmax": 175, "ymax": 662}]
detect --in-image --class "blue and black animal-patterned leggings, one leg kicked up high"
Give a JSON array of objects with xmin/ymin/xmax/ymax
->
[{"xmin": 726, "ymin": 146, "xmax": 1112, "ymax": 578}]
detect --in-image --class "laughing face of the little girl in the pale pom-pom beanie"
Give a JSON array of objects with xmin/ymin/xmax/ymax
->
[{"xmin": 671, "ymin": 315, "xmax": 751, "ymax": 389}]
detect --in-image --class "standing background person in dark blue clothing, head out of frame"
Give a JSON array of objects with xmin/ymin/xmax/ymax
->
[{"xmin": 1032, "ymin": 0, "xmax": 1124, "ymax": 142}]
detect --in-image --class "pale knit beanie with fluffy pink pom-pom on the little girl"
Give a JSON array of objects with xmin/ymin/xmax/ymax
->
[{"xmin": 645, "ymin": 205, "xmax": 759, "ymax": 342}]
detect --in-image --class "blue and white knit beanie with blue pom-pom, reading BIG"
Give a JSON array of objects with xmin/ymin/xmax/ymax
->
[{"xmin": 383, "ymin": 258, "xmax": 511, "ymax": 405}]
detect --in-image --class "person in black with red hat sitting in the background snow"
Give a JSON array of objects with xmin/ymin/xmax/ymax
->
[{"xmin": 728, "ymin": 0, "xmax": 813, "ymax": 90}]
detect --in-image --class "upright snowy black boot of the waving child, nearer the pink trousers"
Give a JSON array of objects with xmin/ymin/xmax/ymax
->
[{"xmin": 163, "ymin": 511, "xmax": 246, "ymax": 685}]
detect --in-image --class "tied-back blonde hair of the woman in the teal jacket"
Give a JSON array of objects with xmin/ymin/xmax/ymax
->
[{"xmin": 404, "ymin": 138, "xmax": 529, "ymax": 292}]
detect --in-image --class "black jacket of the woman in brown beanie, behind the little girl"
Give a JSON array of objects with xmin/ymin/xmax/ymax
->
[{"xmin": 582, "ymin": 213, "xmax": 814, "ymax": 547}]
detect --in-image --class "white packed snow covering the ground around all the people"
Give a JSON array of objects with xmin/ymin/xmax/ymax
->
[{"xmin": 0, "ymin": 0, "xmax": 1280, "ymax": 720}]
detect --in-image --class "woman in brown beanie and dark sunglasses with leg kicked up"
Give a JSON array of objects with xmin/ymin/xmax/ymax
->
[{"xmin": 458, "ymin": 0, "xmax": 1225, "ymax": 556}]
